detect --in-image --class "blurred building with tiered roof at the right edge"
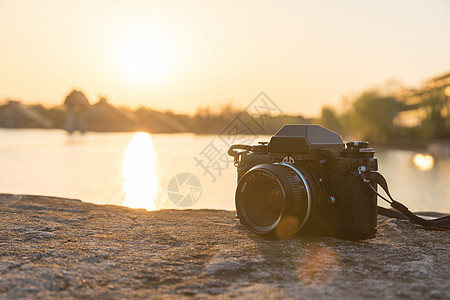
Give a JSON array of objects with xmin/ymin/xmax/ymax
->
[{"xmin": 394, "ymin": 72, "xmax": 450, "ymax": 138}]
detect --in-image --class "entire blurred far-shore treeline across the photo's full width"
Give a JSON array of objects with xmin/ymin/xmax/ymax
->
[{"xmin": 0, "ymin": 77, "xmax": 450, "ymax": 143}]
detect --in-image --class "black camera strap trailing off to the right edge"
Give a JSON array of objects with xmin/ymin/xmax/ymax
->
[{"xmin": 359, "ymin": 168, "xmax": 450, "ymax": 230}]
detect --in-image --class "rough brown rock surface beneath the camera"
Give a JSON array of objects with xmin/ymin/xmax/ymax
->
[{"xmin": 0, "ymin": 194, "xmax": 450, "ymax": 299}]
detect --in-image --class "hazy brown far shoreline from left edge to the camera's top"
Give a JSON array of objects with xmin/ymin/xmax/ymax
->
[{"xmin": 0, "ymin": 90, "xmax": 313, "ymax": 134}]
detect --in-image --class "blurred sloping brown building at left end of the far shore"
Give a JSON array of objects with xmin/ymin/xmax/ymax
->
[{"xmin": 0, "ymin": 100, "xmax": 53, "ymax": 128}]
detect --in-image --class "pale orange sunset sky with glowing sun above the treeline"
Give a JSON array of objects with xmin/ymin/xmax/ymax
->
[{"xmin": 0, "ymin": 0, "xmax": 450, "ymax": 116}]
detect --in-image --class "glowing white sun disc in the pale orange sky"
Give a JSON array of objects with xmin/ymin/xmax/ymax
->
[{"xmin": 118, "ymin": 32, "xmax": 174, "ymax": 83}]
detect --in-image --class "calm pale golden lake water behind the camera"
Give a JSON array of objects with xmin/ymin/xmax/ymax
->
[{"xmin": 0, "ymin": 129, "xmax": 450, "ymax": 213}]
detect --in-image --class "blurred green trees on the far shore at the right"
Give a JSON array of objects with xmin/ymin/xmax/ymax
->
[{"xmin": 316, "ymin": 89, "xmax": 450, "ymax": 145}]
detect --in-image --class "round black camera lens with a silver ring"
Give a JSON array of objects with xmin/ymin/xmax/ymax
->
[{"xmin": 236, "ymin": 164, "xmax": 318, "ymax": 237}]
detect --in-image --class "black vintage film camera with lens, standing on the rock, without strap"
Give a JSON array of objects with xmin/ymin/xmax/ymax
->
[{"xmin": 228, "ymin": 125, "xmax": 377, "ymax": 240}]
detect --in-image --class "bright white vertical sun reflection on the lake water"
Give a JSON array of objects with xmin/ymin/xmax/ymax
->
[{"xmin": 122, "ymin": 132, "xmax": 159, "ymax": 210}]
